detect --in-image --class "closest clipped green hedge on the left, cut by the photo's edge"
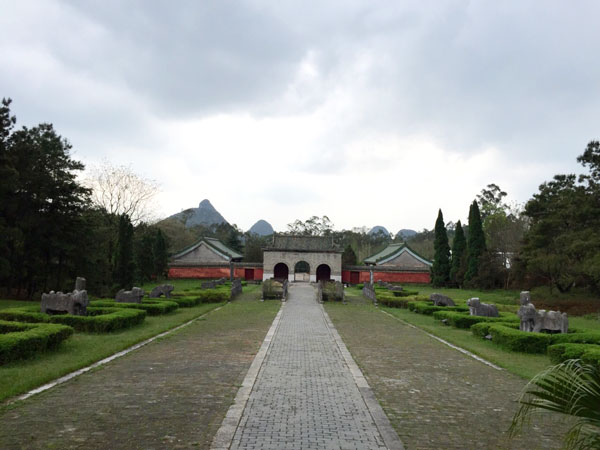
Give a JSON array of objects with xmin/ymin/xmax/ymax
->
[{"xmin": 0, "ymin": 320, "xmax": 73, "ymax": 364}]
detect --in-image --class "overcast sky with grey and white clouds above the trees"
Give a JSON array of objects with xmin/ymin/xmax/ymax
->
[{"xmin": 0, "ymin": 0, "xmax": 600, "ymax": 233}]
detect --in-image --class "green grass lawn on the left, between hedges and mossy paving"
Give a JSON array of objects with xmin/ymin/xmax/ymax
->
[{"xmin": 0, "ymin": 280, "xmax": 260, "ymax": 401}]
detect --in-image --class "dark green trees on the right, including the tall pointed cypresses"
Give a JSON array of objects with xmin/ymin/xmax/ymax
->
[{"xmin": 432, "ymin": 141, "xmax": 600, "ymax": 294}]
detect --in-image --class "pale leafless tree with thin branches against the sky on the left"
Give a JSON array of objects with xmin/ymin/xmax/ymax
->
[{"xmin": 84, "ymin": 161, "xmax": 159, "ymax": 225}]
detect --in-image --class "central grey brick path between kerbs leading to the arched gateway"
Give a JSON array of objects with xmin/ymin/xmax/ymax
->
[{"xmin": 231, "ymin": 284, "xmax": 394, "ymax": 450}]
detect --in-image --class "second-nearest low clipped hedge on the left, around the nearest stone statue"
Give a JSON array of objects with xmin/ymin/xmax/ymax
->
[{"xmin": 0, "ymin": 306, "xmax": 146, "ymax": 333}]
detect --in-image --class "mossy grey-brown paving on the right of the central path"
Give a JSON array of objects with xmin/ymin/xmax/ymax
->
[{"xmin": 326, "ymin": 304, "xmax": 569, "ymax": 450}]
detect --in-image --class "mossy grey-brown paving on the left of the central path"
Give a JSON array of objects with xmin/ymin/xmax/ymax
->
[{"xmin": 0, "ymin": 302, "xmax": 276, "ymax": 450}]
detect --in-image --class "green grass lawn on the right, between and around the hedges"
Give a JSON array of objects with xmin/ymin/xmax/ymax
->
[{"xmin": 346, "ymin": 286, "xmax": 600, "ymax": 379}]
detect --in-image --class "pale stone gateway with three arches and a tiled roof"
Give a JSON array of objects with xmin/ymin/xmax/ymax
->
[{"xmin": 263, "ymin": 235, "xmax": 342, "ymax": 281}]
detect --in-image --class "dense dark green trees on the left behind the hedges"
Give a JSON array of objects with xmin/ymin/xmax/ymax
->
[{"xmin": 0, "ymin": 99, "xmax": 167, "ymax": 298}]
